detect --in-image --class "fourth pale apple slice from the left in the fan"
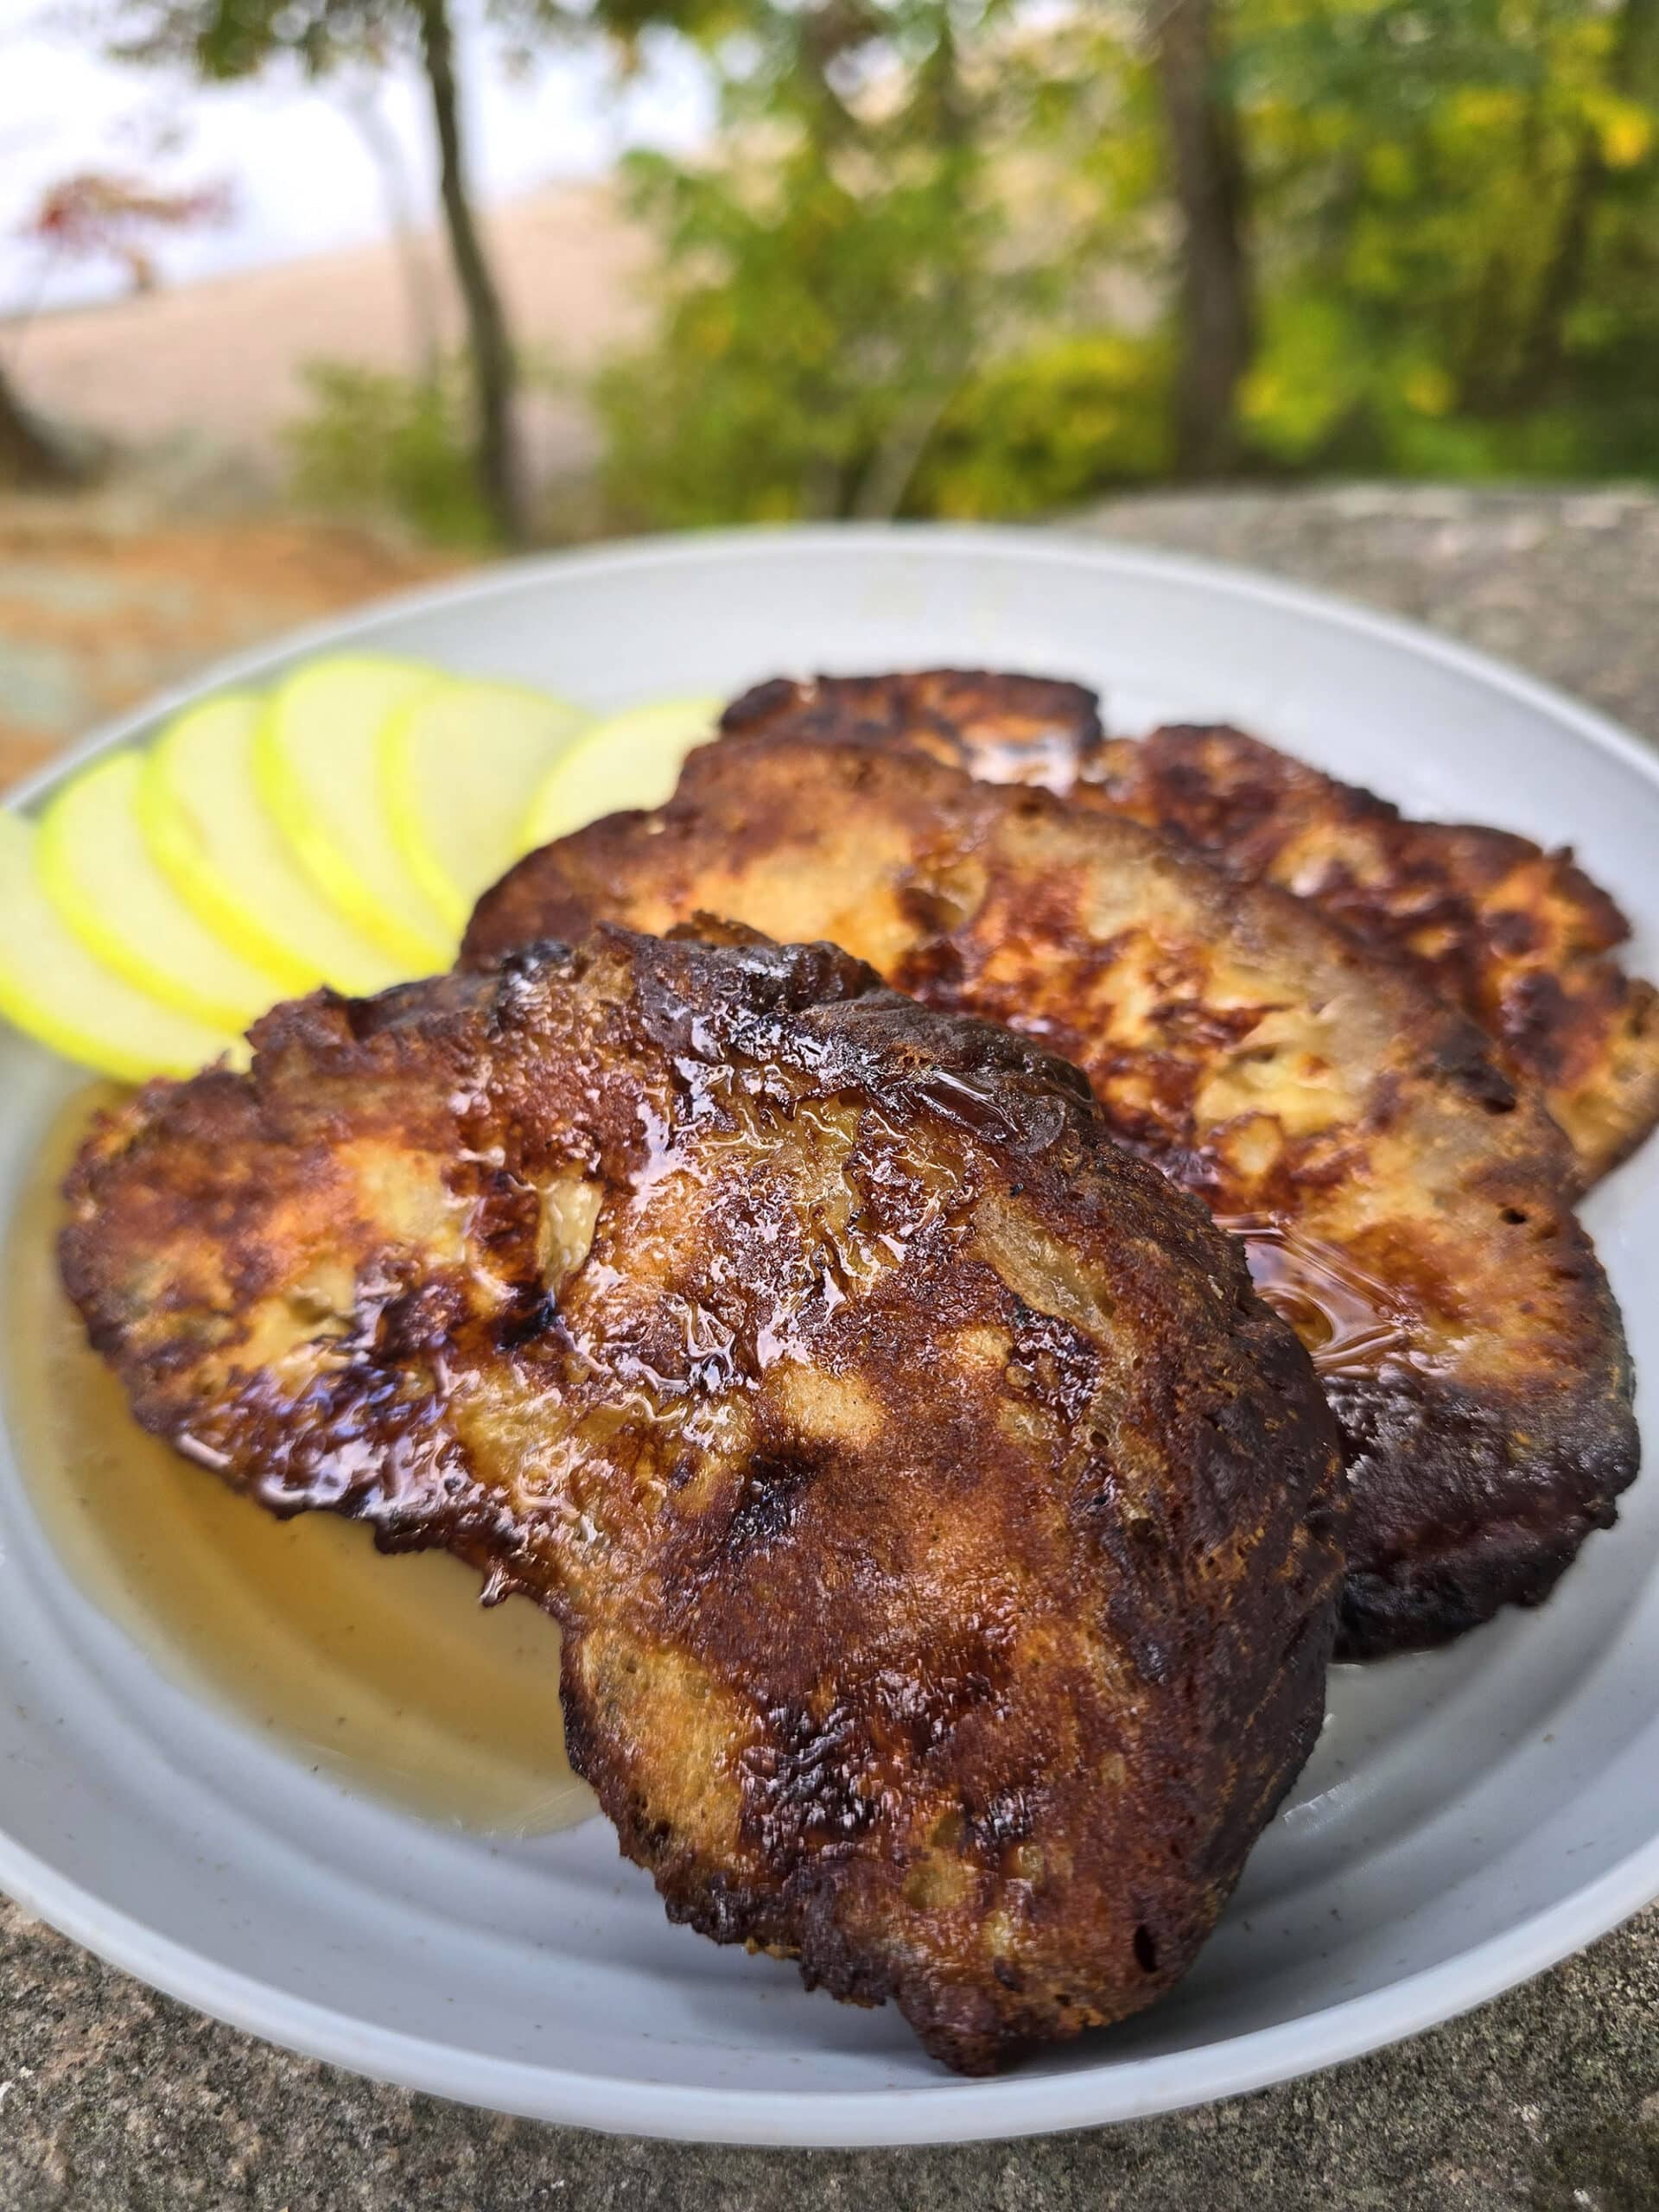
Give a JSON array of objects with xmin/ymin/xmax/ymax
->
[{"xmin": 254, "ymin": 652, "xmax": 455, "ymax": 976}]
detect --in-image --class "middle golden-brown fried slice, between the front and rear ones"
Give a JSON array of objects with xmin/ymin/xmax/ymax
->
[{"xmin": 465, "ymin": 734, "xmax": 1637, "ymax": 1656}]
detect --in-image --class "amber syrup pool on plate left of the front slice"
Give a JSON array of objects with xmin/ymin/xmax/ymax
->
[{"xmin": 4, "ymin": 1090, "xmax": 593, "ymax": 1834}]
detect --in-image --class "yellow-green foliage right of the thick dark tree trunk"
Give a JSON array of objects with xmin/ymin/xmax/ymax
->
[{"xmin": 1234, "ymin": 0, "xmax": 1659, "ymax": 475}]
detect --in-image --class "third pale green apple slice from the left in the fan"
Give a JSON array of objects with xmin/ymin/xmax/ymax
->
[{"xmin": 139, "ymin": 692, "xmax": 407, "ymax": 998}]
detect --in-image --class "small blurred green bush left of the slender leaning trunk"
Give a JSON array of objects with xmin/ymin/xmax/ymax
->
[{"xmin": 288, "ymin": 360, "xmax": 495, "ymax": 549}]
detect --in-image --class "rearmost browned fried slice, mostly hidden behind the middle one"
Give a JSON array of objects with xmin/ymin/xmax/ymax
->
[{"xmin": 723, "ymin": 668, "xmax": 1659, "ymax": 1184}]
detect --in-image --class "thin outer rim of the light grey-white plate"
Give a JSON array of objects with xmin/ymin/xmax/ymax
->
[{"xmin": 0, "ymin": 524, "xmax": 1659, "ymax": 2148}]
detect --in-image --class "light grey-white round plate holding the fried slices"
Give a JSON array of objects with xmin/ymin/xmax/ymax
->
[{"xmin": 0, "ymin": 529, "xmax": 1659, "ymax": 2144}]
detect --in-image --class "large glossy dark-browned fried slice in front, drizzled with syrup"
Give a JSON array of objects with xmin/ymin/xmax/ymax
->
[{"xmin": 62, "ymin": 929, "xmax": 1343, "ymax": 2070}]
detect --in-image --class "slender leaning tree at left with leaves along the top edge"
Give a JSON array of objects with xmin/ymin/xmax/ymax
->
[{"xmin": 113, "ymin": 0, "xmax": 528, "ymax": 544}]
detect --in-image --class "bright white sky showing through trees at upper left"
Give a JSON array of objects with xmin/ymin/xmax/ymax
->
[{"xmin": 0, "ymin": 0, "xmax": 708, "ymax": 316}]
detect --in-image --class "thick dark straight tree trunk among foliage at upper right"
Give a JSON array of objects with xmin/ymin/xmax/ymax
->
[{"xmin": 1154, "ymin": 0, "xmax": 1256, "ymax": 475}]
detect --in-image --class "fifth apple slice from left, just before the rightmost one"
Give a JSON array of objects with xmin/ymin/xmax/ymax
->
[{"xmin": 380, "ymin": 679, "xmax": 588, "ymax": 933}]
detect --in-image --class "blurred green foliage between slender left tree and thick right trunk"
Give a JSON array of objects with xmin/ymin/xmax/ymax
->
[{"xmin": 597, "ymin": 0, "xmax": 1146, "ymax": 522}]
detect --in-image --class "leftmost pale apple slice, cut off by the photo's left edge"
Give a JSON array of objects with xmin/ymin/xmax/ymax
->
[{"xmin": 0, "ymin": 807, "xmax": 237, "ymax": 1084}]
